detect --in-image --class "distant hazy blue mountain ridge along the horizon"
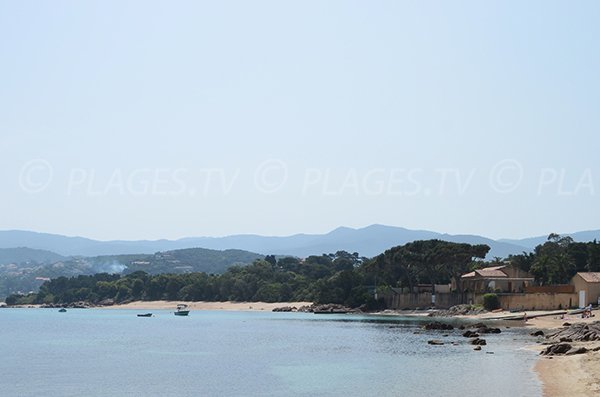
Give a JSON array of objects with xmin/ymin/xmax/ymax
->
[{"xmin": 0, "ymin": 225, "xmax": 600, "ymax": 259}]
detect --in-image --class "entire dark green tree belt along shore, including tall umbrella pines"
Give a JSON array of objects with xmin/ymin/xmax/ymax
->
[{"xmin": 7, "ymin": 240, "xmax": 496, "ymax": 308}]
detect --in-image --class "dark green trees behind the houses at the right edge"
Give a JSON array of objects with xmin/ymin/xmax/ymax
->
[{"xmin": 508, "ymin": 233, "xmax": 600, "ymax": 285}]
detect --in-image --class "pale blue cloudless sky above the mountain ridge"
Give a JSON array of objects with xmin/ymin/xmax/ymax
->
[{"xmin": 0, "ymin": 0, "xmax": 600, "ymax": 240}]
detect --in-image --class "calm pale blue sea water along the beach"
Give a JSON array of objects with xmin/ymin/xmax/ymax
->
[{"xmin": 0, "ymin": 309, "xmax": 541, "ymax": 397}]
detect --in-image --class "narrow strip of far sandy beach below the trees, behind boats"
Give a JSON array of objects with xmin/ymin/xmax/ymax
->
[{"xmin": 101, "ymin": 301, "xmax": 312, "ymax": 311}]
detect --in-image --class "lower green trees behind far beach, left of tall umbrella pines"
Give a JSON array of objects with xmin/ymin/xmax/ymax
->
[{"xmin": 6, "ymin": 251, "xmax": 370, "ymax": 306}]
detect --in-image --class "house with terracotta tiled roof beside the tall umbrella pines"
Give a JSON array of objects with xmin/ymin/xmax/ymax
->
[{"xmin": 460, "ymin": 265, "xmax": 534, "ymax": 294}]
